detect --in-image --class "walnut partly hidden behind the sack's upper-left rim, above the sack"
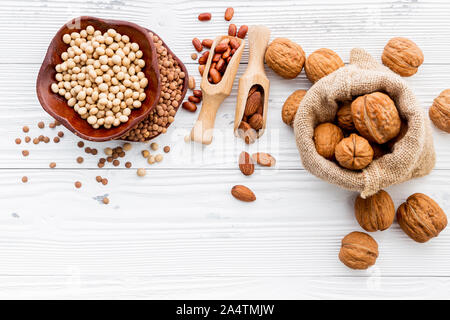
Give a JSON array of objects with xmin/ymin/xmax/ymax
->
[{"xmin": 305, "ymin": 48, "xmax": 344, "ymax": 83}]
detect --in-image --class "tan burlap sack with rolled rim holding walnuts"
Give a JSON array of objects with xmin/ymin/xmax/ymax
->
[{"xmin": 294, "ymin": 49, "xmax": 436, "ymax": 198}]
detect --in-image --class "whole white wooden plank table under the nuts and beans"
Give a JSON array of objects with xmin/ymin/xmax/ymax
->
[{"xmin": 0, "ymin": 0, "xmax": 450, "ymax": 299}]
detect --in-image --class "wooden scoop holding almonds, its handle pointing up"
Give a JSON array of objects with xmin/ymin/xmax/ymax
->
[{"xmin": 234, "ymin": 26, "xmax": 270, "ymax": 138}]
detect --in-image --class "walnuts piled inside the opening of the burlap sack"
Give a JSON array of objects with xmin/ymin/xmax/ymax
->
[{"xmin": 314, "ymin": 92, "xmax": 407, "ymax": 170}]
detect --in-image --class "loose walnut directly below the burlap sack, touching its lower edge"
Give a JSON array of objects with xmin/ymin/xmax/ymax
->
[{"xmin": 355, "ymin": 190, "xmax": 395, "ymax": 232}]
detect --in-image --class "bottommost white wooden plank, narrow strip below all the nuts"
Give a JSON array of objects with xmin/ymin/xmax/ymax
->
[{"xmin": 0, "ymin": 276, "xmax": 450, "ymax": 300}]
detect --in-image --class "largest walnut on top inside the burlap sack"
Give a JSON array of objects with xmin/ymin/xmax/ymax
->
[{"xmin": 352, "ymin": 92, "xmax": 401, "ymax": 144}]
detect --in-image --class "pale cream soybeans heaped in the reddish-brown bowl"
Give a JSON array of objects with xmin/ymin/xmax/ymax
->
[{"xmin": 51, "ymin": 26, "xmax": 148, "ymax": 129}]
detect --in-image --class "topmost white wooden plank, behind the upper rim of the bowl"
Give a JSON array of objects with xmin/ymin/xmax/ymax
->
[{"xmin": 0, "ymin": 0, "xmax": 450, "ymax": 63}]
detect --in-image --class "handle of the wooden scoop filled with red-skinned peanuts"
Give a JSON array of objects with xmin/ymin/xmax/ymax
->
[{"xmin": 191, "ymin": 95, "xmax": 226, "ymax": 144}]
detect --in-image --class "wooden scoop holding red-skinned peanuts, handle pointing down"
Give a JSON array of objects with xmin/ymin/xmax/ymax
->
[{"xmin": 191, "ymin": 36, "xmax": 245, "ymax": 144}]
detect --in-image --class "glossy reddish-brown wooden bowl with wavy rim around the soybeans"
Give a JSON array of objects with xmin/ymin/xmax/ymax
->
[{"xmin": 36, "ymin": 16, "xmax": 161, "ymax": 142}]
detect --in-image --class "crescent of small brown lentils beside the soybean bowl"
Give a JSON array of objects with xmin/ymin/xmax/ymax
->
[{"xmin": 122, "ymin": 33, "xmax": 186, "ymax": 142}]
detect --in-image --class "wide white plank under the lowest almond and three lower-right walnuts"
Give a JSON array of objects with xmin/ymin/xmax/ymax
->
[{"xmin": 0, "ymin": 169, "xmax": 450, "ymax": 277}]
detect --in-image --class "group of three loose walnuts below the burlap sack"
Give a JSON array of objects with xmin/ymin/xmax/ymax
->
[{"xmin": 339, "ymin": 190, "xmax": 447, "ymax": 269}]
